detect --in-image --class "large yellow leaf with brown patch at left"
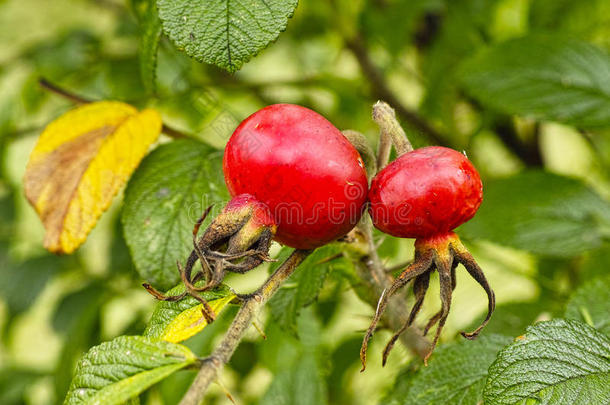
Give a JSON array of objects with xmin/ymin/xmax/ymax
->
[{"xmin": 24, "ymin": 101, "xmax": 162, "ymax": 253}]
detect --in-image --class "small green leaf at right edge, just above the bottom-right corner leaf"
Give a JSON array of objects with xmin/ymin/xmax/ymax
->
[{"xmin": 565, "ymin": 275, "xmax": 610, "ymax": 336}]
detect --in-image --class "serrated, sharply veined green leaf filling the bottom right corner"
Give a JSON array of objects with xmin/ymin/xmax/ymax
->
[{"xmin": 484, "ymin": 319, "xmax": 610, "ymax": 405}]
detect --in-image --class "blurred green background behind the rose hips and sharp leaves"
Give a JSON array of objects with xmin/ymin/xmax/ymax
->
[{"xmin": 0, "ymin": 0, "xmax": 610, "ymax": 405}]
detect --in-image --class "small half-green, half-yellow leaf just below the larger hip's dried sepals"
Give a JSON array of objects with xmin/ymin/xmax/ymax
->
[{"xmin": 144, "ymin": 281, "xmax": 235, "ymax": 343}]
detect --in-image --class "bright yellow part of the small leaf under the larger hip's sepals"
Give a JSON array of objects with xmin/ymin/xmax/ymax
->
[{"xmin": 161, "ymin": 294, "xmax": 235, "ymax": 343}]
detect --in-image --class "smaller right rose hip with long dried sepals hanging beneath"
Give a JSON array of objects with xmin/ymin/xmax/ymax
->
[{"xmin": 360, "ymin": 146, "xmax": 495, "ymax": 370}]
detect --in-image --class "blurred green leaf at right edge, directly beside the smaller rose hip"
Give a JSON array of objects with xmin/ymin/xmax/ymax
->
[{"xmin": 460, "ymin": 171, "xmax": 610, "ymax": 257}]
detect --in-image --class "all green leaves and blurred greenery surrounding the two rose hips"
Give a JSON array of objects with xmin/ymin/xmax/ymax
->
[{"xmin": 0, "ymin": 0, "xmax": 610, "ymax": 405}]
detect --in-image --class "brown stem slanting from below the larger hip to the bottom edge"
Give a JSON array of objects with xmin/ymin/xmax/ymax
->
[{"xmin": 180, "ymin": 250, "xmax": 312, "ymax": 405}]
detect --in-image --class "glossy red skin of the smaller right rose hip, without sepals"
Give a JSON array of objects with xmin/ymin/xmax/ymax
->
[{"xmin": 369, "ymin": 146, "xmax": 483, "ymax": 238}]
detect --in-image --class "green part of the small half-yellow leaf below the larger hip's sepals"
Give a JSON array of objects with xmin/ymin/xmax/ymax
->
[{"xmin": 144, "ymin": 281, "xmax": 233, "ymax": 340}]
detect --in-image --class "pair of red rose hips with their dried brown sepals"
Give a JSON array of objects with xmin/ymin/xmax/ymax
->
[{"xmin": 153, "ymin": 104, "xmax": 494, "ymax": 364}]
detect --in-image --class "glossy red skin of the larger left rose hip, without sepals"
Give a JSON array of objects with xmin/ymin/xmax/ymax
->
[{"xmin": 223, "ymin": 104, "xmax": 368, "ymax": 249}]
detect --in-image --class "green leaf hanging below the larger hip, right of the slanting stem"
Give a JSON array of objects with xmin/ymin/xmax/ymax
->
[{"xmin": 269, "ymin": 244, "xmax": 346, "ymax": 334}]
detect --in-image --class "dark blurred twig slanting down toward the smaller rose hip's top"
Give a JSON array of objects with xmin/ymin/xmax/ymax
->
[{"xmin": 344, "ymin": 35, "xmax": 449, "ymax": 146}]
